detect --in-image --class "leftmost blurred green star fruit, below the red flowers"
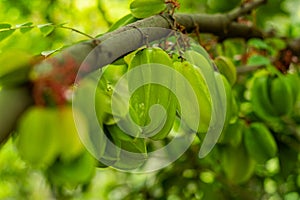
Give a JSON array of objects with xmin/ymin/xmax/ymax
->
[{"xmin": 17, "ymin": 107, "xmax": 60, "ymax": 167}]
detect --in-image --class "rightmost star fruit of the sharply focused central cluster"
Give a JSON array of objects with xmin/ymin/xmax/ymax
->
[{"xmin": 184, "ymin": 48, "xmax": 233, "ymax": 157}]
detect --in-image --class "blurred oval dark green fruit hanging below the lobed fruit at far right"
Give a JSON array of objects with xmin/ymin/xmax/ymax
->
[{"xmin": 244, "ymin": 122, "xmax": 277, "ymax": 164}]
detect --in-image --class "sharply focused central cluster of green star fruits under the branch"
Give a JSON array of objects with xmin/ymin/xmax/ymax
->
[{"xmin": 91, "ymin": 47, "xmax": 234, "ymax": 169}]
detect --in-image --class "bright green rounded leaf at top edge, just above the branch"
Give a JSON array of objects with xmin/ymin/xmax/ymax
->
[{"xmin": 130, "ymin": 0, "xmax": 166, "ymax": 18}]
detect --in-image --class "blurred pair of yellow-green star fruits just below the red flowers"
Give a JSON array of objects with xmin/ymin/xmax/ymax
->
[{"xmin": 16, "ymin": 106, "xmax": 88, "ymax": 167}]
